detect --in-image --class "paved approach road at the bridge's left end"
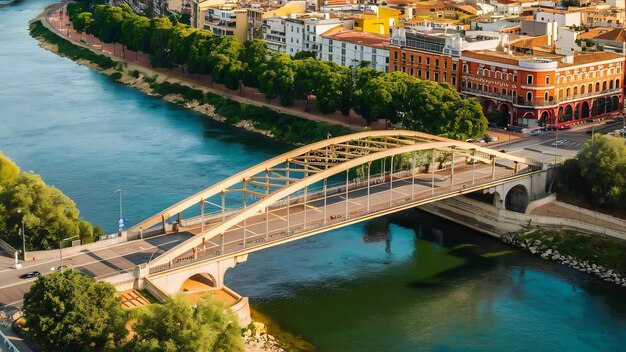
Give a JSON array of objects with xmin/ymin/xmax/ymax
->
[{"xmin": 0, "ymin": 233, "xmax": 191, "ymax": 307}]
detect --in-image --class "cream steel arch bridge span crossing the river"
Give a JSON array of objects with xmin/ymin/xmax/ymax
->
[{"xmin": 129, "ymin": 130, "xmax": 546, "ymax": 284}]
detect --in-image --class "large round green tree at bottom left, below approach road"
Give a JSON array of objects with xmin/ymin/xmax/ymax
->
[{"xmin": 24, "ymin": 270, "xmax": 127, "ymax": 351}]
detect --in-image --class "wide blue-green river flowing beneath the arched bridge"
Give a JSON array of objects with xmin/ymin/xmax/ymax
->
[{"xmin": 0, "ymin": 0, "xmax": 626, "ymax": 351}]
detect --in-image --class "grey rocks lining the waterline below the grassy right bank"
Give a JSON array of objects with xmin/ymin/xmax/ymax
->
[{"xmin": 501, "ymin": 230, "xmax": 626, "ymax": 287}]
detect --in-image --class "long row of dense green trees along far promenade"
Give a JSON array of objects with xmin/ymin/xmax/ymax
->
[{"xmin": 71, "ymin": 5, "xmax": 487, "ymax": 140}]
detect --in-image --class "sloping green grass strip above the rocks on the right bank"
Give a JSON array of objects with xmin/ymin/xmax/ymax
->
[{"xmin": 517, "ymin": 229, "xmax": 626, "ymax": 275}]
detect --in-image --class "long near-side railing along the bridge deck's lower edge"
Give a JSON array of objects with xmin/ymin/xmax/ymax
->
[{"xmin": 150, "ymin": 167, "xmax": 537, "ymax": 274}]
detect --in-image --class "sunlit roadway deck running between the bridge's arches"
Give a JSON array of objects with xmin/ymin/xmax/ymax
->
[{"xmin": 155, "ymin": 158, "xmax": 528, "ymax": 272}]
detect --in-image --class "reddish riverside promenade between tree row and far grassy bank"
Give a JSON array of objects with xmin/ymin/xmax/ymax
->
[{"xmin": 40, "ymin": 5, "xmax": 386, "ymax": 130}]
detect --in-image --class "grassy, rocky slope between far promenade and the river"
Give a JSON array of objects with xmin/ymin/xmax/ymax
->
[{"xmin": 30, "ymin": 15, "xmax": 354, "ymax": 145}]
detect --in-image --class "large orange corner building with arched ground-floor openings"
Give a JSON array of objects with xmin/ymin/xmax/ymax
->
[{"xmin": 459, "ymin": 50, "xmax": 626, "ymax": 127}]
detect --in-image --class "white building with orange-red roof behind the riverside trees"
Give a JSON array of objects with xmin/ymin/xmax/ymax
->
[{"xmin": 322, "ymin": 30, "xmax": 390, "ymax": 72}]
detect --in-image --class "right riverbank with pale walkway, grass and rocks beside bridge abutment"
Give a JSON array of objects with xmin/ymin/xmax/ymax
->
[{"xmin": 420, "ymin": 196, "xmax": 626, "ymax": 287}]
